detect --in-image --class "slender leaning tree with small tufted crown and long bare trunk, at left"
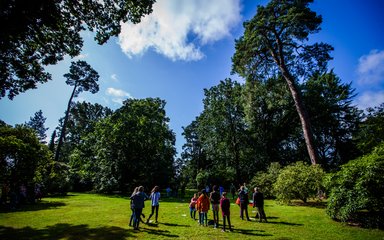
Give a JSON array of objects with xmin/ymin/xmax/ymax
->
[{"xmin": 55, "ymin": 60, "xmax": 99, "ymax": 161}]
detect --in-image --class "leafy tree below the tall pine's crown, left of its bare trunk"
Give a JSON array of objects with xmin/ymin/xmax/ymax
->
[{"xmin": 243, "ymin": 77, "xmax": 301, "ymax": 167}]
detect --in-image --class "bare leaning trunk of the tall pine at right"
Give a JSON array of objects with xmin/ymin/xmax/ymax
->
[{"xmin": 279, "ymin": 65, "xmax": 318, "ymax": 165}]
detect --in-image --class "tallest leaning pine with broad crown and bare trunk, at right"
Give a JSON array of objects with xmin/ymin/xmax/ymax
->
[{"xmin": 232, "ymin": 0, "xmax": 333, "ymax": 164}]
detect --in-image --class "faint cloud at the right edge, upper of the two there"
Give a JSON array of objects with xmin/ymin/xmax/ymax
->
[{"xmin": 357, "ymin": 50, "xmax": 384, "ymax": 85}]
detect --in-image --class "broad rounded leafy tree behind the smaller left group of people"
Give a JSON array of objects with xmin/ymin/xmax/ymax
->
[{"xmin": 89, "ymin": 98, "xmax": 176, "ymax": 192}]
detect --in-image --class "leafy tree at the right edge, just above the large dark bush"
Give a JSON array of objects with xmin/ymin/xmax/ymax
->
[{"xmin": 355, "ymin": 103, "xmax": 384, "ymax": 154}]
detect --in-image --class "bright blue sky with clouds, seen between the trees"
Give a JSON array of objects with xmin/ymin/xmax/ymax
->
[{"xmin": 0, "ymin": 0, "xmax": 384, "ymax": 157}]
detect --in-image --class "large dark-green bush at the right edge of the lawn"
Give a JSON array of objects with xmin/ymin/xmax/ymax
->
[{"xmin": 327, "ymin": 144, "xmax": 384, "ymax": 227}]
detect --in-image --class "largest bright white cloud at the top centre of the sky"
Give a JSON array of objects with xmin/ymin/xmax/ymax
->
[{"xmin": 119, "ymin": 0, "xmax": 241, "ymax": 61}]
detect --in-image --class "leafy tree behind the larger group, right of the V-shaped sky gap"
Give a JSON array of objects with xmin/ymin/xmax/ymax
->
[{"xmin": 198, "ymin": 79, "xmax": 250, "ymax": 182}]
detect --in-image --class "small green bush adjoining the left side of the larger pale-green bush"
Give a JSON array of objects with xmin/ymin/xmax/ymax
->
[{"xmin": 249, "ymin": 162, "xmax": 281, "ymax": 198}]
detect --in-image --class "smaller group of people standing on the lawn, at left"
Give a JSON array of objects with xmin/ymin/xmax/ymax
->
[{"xmin": 129, "ymin": 186, "xmax": 160, "ymax": 230}]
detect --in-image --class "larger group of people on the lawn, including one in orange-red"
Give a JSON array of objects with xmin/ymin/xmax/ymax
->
[{"xmin": 189, "ymin": 184, "xmax": 267, "ymax": 232}]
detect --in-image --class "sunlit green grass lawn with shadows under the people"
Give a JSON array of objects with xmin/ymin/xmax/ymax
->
[{"xmin": 0, "ymin": 193, "xmax": 384, "ymax": 240}]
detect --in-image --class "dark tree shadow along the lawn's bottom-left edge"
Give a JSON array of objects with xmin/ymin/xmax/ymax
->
[{"xmin": 0, "ymin": 223, "xmax": 134, "ymax": 240}]
